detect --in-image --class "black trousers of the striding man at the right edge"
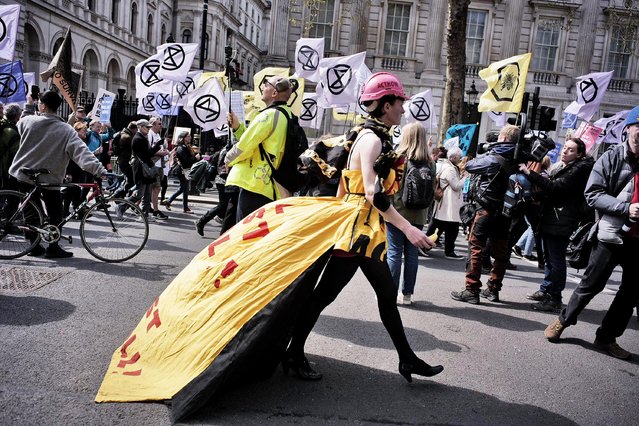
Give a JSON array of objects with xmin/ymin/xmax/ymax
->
[{"xmin": 559, "ymin": 238, "xmax": 639, "ymax": 343}]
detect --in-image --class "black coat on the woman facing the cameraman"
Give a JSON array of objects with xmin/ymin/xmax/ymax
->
[{"xmin": 528, "ymin": 157, "xmax": 595, "ymax": 236}]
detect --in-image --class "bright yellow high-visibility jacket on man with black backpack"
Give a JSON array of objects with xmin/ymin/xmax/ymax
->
[{"xmin": 226, "ymin": 105, "xmax": 291, "ymax": 200}]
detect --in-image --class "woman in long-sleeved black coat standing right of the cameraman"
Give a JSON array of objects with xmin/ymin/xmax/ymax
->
[{"xmin": 519, "ymin": 138, "xmax": 594, "ymax": 312}]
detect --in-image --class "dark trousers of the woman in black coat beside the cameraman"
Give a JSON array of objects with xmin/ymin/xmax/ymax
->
[{"xmin": 540, "ymin": 233, "xmax": 570, "ymax": 302}]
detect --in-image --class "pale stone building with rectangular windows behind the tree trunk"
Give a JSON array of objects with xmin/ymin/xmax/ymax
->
[{"xmin": 284, "ymin": 0, "xmax": 639, "ymax": 135}]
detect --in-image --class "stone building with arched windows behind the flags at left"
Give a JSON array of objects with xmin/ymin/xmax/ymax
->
[{"xmin": 10, "ymin": 0, "xmax": 270, "ymax": 96}]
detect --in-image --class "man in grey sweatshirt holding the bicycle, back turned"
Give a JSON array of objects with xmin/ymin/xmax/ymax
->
[{"xmin": 9, "ymin": 91, "xmax": 107, "ymax": 258}]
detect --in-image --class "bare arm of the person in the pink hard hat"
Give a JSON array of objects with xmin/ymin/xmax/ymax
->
[{"xmin": 360, "ymin": 133, "xmax": 434, "ymax": 250}]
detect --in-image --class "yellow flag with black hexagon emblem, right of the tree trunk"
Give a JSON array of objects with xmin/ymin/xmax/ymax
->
[{"xmin": 478, "ymin": 53, "xmax": 532, "ymax": 112}]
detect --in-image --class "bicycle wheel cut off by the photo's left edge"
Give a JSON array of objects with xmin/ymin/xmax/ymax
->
[{"xmin": 0, "ymin": 191, "xmax": 42, "ymax": 259}]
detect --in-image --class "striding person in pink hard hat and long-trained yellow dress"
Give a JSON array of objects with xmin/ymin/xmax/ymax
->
[{"xmin": 96, "ymin": 73, "xmax": 443, "ymax": 421}]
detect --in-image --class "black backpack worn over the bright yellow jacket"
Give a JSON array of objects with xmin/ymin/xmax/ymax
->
[{"xmin": 260, "ymin": 105, "xmax": 308, "ymax": 195}]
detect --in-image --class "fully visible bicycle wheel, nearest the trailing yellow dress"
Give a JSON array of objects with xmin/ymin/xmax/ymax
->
[{"xmin": 80, "ymin": 198, "xmax": 149, "ymax": 262}]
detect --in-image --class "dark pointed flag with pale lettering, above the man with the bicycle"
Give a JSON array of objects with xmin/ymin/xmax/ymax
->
[{"xmin": 40, "ymin": 28, "xmax": 82, "ymax": 111}]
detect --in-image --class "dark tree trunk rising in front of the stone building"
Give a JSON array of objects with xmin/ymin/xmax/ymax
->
[{"xmin": 439, "ymin": 0, "xmax": 470, "ymax": 143}]
